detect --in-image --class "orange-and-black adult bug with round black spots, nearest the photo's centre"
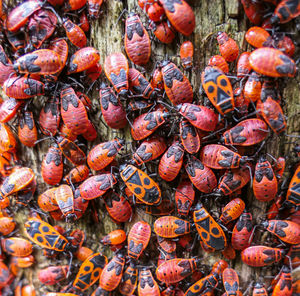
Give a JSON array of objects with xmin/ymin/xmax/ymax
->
[{"xmin": 119, "ymin": 165, "xmax": 161, "ymax": 205}]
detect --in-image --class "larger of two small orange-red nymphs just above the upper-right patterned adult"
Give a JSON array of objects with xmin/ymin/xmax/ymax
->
[{"xmin": 217, "ymin": 32, "xmax": 239, "ymax": 62}]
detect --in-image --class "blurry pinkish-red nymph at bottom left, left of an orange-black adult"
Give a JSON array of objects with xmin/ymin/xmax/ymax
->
[{"xmin": 38, "ymin": 265, "xmax": 69, "ymax": 285}]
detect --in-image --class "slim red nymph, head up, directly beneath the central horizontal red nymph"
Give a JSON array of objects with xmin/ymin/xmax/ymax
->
[{"xmin": 179, "ymin": 118, "xmax": 200, "ymax": 154}]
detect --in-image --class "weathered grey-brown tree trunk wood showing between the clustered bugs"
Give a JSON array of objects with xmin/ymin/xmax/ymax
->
[{"xmin": 3, "ymin": 0, "xmax": 300, "ymax": 295}]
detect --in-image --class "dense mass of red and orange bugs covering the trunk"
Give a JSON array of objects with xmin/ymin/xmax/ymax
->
[{"xmin": 0, "ymin": 0, "xmax": 300, "ymax": 296}]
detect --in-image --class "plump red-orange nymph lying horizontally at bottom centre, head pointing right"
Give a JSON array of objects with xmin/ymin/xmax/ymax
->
[{"xmin": 155, "ymin": 258, "xmax": 201, "ymax": 285}]
